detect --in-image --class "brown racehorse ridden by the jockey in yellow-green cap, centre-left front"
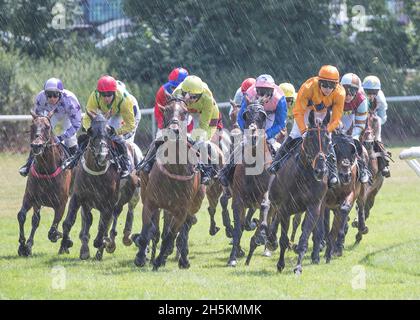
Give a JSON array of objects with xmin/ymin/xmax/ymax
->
[{"xmin": 134, "ymin": 98, "xmax": 205, "ymax": 270}]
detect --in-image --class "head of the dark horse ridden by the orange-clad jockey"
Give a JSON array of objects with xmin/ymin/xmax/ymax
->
[{"xmin": 302, "ymin": 111, "xmax": 331, "ymax": 181}]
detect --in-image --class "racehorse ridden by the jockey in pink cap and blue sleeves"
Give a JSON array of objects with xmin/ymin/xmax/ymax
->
[{"xmin": 228, "ymin": 101, "xmax": 272, "ymax": 266}]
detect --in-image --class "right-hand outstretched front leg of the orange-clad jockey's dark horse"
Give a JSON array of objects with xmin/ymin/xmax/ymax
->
[{"xmin": 293, "ymin": 201, "xmax": 321, "ymax": 274}]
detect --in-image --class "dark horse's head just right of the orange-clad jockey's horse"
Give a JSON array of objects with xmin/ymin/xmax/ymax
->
[{"xmin": 332, "ymin": 134, "xmax": 357, "ymax": 185}]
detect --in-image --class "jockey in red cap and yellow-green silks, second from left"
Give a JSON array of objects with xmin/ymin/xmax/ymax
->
[{"xmin": 67, "ymin": 75, "xmax": 136, "ymax": 178}]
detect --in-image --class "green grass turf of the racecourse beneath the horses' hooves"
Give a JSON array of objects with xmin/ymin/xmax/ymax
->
[{"xmin": 0, "ymin": 149, "xmax": 420, "ymax": 300}]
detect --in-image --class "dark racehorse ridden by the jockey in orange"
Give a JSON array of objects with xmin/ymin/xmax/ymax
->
[{"xmin": 247, "ymin": 111, "xmax": 331, "ymax": 274}]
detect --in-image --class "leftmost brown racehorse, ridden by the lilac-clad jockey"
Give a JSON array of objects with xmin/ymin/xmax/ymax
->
[{"xmin": 18, "ymin": 111, "xmax": 71, "ymax": 256}]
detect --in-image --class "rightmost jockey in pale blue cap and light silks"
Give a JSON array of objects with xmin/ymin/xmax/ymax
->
[{"xmin": 362, "ymin": 76, "xmax": 391, "ymax": 178}]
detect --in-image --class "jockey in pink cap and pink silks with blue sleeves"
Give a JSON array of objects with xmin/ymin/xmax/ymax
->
[{"xmin": 219, "ymin": 74, "xmax": 287, "ymax": 187}]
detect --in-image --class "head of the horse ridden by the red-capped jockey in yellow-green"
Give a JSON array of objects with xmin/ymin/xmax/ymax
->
[{"xmin": 87, "ymin": 111, "xmax": 109, "ymax": 166}]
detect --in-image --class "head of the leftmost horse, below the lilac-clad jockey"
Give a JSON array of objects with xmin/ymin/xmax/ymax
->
[{"xmin": 31, "ymin": 110, "xmax": 54, "ymax": 156}]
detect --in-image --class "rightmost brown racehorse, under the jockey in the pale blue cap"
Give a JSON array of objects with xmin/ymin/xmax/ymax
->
[{"xmin": 352, "ymin": 111, "xmax": 390, "ymax": 243}]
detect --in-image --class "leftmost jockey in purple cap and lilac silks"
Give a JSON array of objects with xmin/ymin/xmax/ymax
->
[{"xmin": 19, "ymin": 78, "xmax": 81, "ymax": 177}]
